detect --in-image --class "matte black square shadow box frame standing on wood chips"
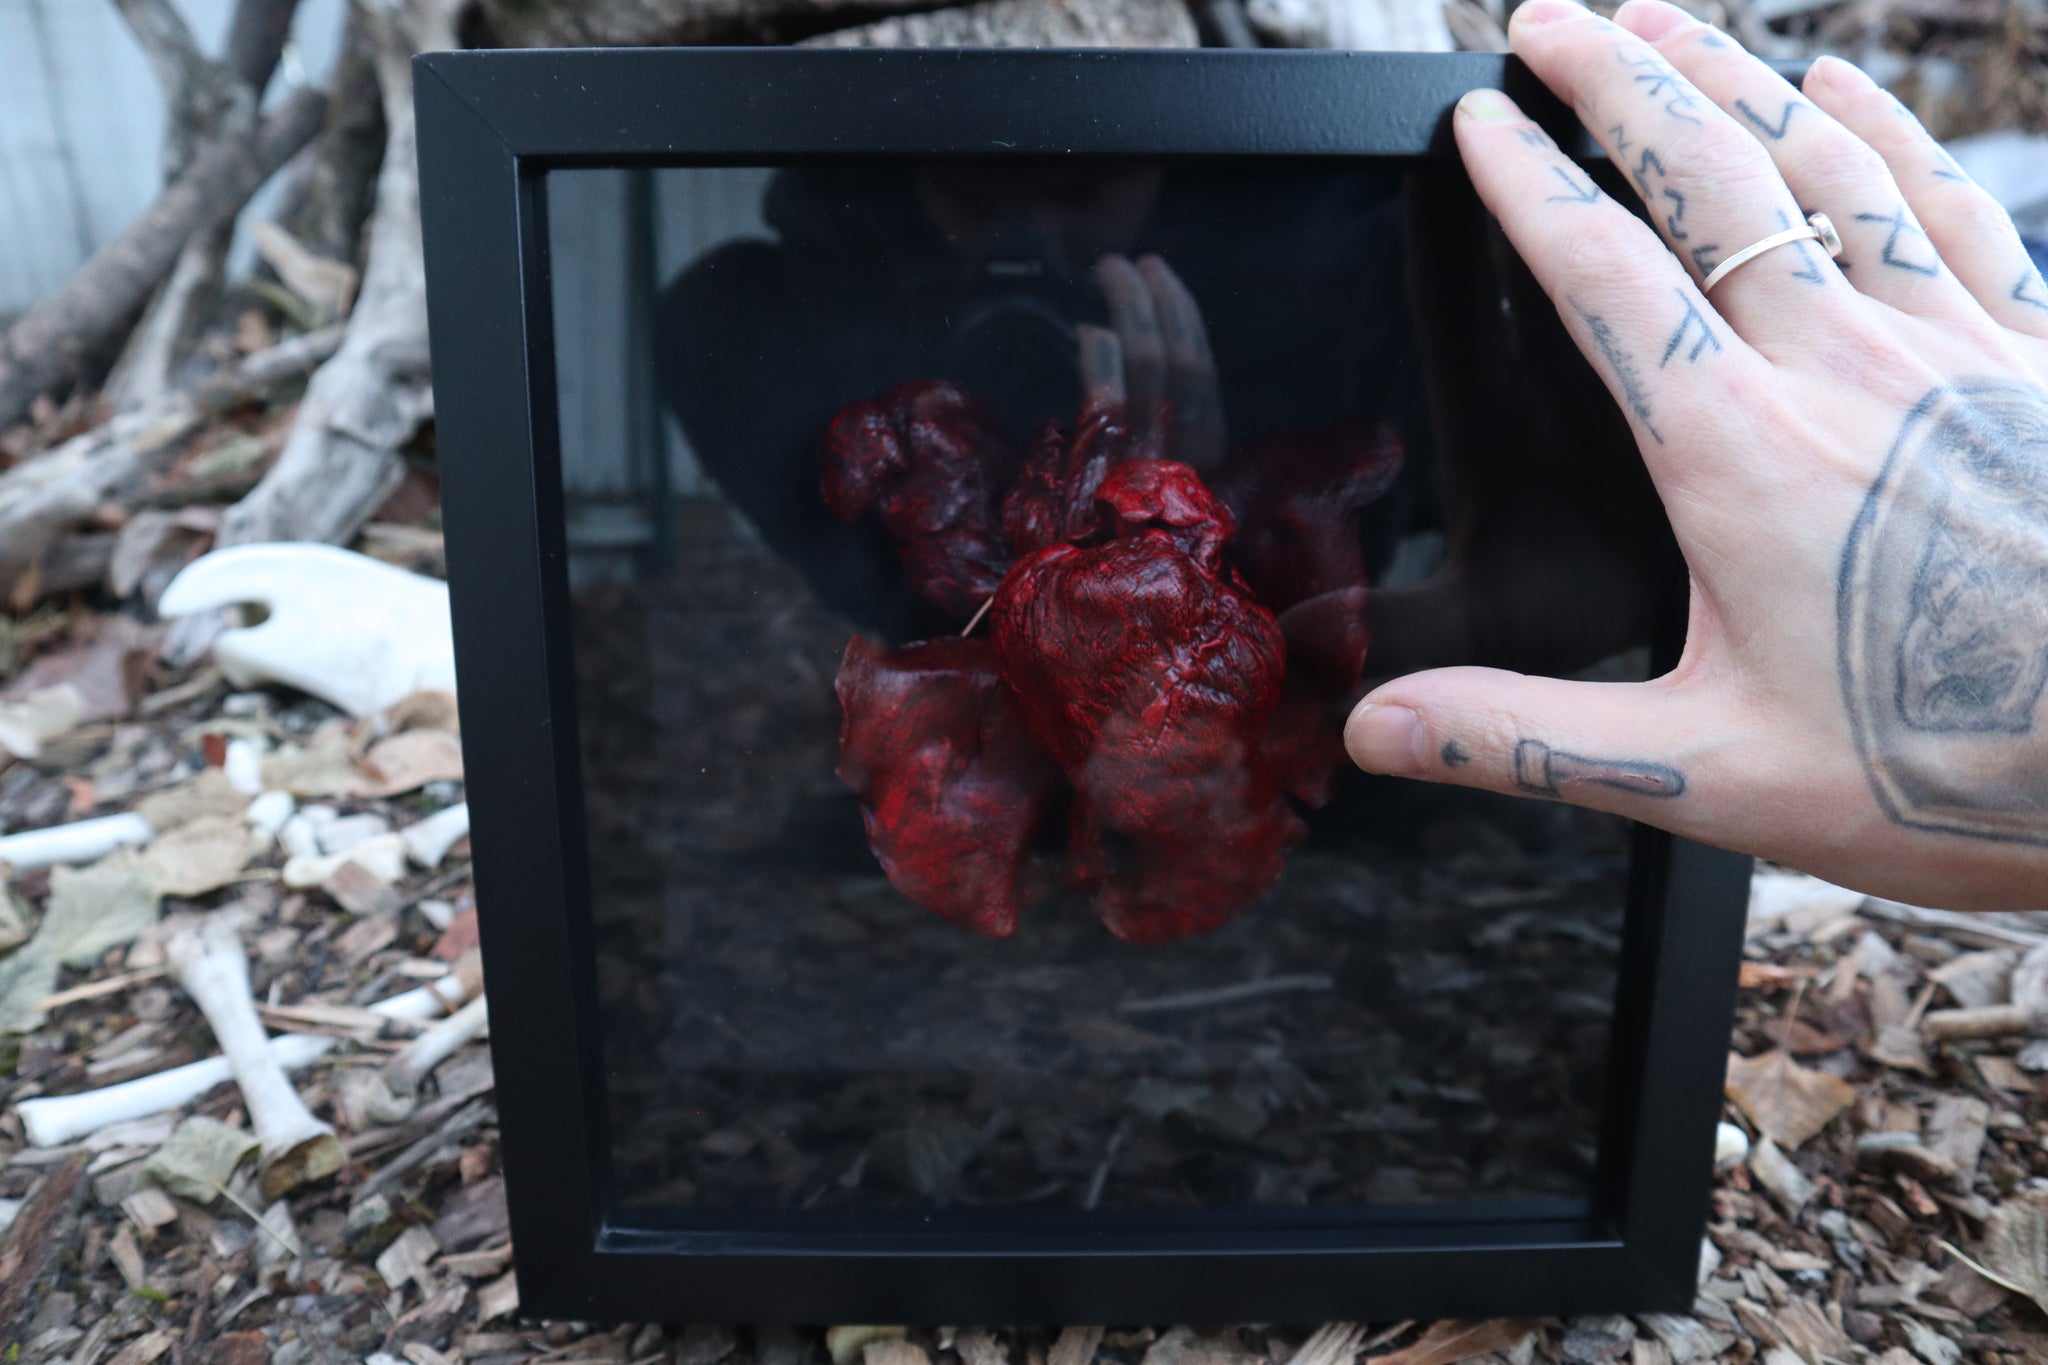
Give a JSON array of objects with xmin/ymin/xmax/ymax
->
[{"xmin": 414, "ymin": 49, "xmax": 1749, "ymax": 1322}]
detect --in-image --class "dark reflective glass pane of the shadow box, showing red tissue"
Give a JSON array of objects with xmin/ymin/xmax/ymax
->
[{"xmin": 549, "ymin": 162, "xmax": 1665, "ymax": 1216}]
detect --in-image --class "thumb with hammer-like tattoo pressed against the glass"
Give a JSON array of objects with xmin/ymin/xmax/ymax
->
[{"xmin": 1343, "ymin": 667, "xmax": 1712, "ymax": 833}]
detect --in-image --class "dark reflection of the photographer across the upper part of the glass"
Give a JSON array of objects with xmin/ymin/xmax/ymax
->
[{"xmin": 655, "ymin": 162, "xmax": 1663, "ymax": 687}]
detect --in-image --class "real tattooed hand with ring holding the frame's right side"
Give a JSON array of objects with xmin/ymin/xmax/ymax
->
[{"xmin": 1346, "ymin": 0, "xmax": 2048, "ymax": 909}]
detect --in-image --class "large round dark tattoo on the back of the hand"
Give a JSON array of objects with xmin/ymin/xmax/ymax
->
[{"xmin": 1835, "ymin": 381, "xmax": 2048, "ymax": 845}]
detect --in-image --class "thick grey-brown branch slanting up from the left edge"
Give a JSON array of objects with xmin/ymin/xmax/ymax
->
[{"xmin": 0, "ymin": 90, "xmax": 328, "ymax": 426}]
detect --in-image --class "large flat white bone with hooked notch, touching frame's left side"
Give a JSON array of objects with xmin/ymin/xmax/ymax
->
[{"xmin": 156, "ymin": 542, "xmax": 455, "ymax": 716}]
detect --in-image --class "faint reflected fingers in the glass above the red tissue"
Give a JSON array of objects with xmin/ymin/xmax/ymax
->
[{"xmin": 1077, "ymin": 254, "xmax": 1225, "ymax": 471}]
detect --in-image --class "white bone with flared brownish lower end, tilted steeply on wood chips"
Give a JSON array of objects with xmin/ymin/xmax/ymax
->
[{"xmin": 164, "ymin": 913, "xmax": 342, "ymax": 1199}]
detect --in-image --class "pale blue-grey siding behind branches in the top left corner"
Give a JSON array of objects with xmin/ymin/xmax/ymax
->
[{"xmin": 0, "ymin": 0, "xmax": 346, "ymax": 315}]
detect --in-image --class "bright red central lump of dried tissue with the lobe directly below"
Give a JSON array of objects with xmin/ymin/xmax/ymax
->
[{"xmin": 991, "ymin": 460, "xmax": 1303, "ymax": 943}]
